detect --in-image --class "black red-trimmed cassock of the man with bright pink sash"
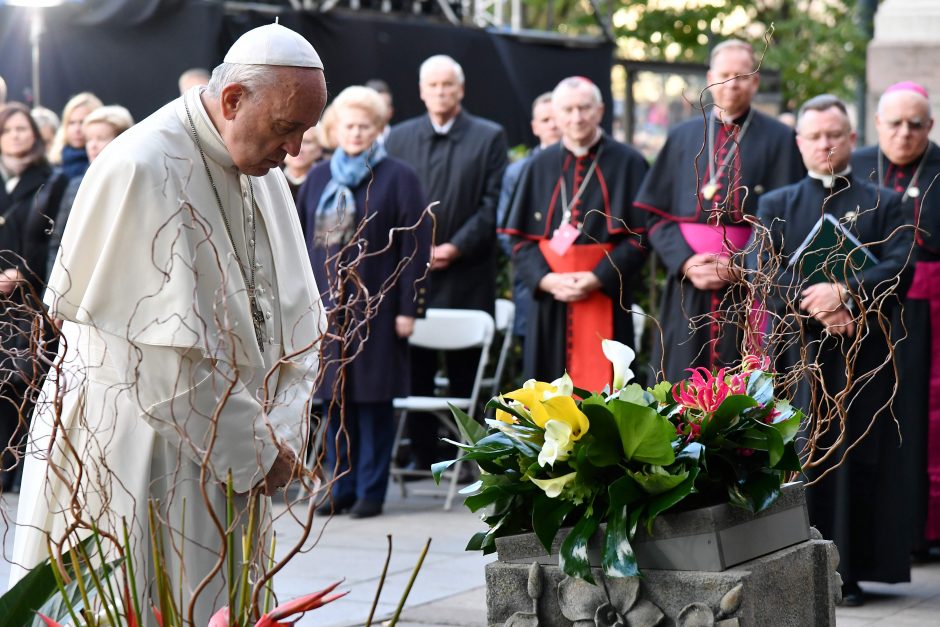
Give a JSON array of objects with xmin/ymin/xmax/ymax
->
[{"xmin": 636, "ymin": 110, "xmax": 806, "ymax": 381}]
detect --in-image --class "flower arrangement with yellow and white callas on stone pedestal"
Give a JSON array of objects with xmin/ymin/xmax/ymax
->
[{"xmin": 432, "ymin": 340, "xmax": 803, "ymax": 583}]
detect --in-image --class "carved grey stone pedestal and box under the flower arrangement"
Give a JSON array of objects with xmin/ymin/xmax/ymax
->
[{"xmin": 486, "ymin": 485, "xmax": 841, "ymax": 627}]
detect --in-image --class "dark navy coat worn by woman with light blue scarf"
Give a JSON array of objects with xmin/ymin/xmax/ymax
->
[{"xmin": 297, "ymin": 157, "xmax": 431, "ymax": 403}]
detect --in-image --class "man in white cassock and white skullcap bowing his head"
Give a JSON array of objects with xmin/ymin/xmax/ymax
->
[{"xmin": 12, "ymin": 24, "xmax": 326, "ymax": 627}]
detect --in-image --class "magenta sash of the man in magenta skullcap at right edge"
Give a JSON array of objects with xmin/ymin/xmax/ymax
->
[{"xmin": 907, "ymin": 261, "xmax": 940, "ymax": 540}]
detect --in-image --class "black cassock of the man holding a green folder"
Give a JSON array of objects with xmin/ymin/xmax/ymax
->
[{"xmin": 752, "ymin": 175, "xmax": 913, "ymax": 582}]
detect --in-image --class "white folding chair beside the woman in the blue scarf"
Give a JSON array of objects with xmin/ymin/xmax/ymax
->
[{"xmin": 391, "ymin": 309, "xmax": 495, "ymax": 510}]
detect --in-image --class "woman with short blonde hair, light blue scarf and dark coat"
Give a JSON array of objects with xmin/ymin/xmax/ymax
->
[{"xmin": 297, "ymin": 86, "xmax": 431, "ymax": 518}]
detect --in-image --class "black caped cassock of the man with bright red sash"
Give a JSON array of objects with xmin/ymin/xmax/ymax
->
[{"xmin": 503, "ymin": 129, "xmax": 647, "ymax": 389}]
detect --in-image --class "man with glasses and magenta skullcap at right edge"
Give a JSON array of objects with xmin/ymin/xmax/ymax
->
[{"xmin": 852, "ymin": 82, "xmax": 940, "ymax": 554}]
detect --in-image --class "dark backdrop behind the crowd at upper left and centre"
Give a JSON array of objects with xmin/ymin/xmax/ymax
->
[{"xmin": 0, "ymin": 0, "xmax": 612, "ymax": 144}]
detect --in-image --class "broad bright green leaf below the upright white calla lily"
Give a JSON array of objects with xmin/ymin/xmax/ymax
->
[{"xmin": 607, "ymin": 400, "xmax": 676, "ymax": 466}]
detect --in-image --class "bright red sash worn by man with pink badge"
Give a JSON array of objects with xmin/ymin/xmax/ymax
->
[{"xmin": 539, "ymin": 240, "xmax": 614, "ymax": 391}]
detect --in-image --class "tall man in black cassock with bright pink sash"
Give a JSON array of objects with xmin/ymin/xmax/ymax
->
[{"xmin": 636, "ymin": 40, "xmax": 805, "ymax": 381}]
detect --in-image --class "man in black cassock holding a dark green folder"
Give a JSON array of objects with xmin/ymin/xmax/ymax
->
[{"xmin": 750, "ymin": 96, "xmax": 913, "ymax": 604}]
